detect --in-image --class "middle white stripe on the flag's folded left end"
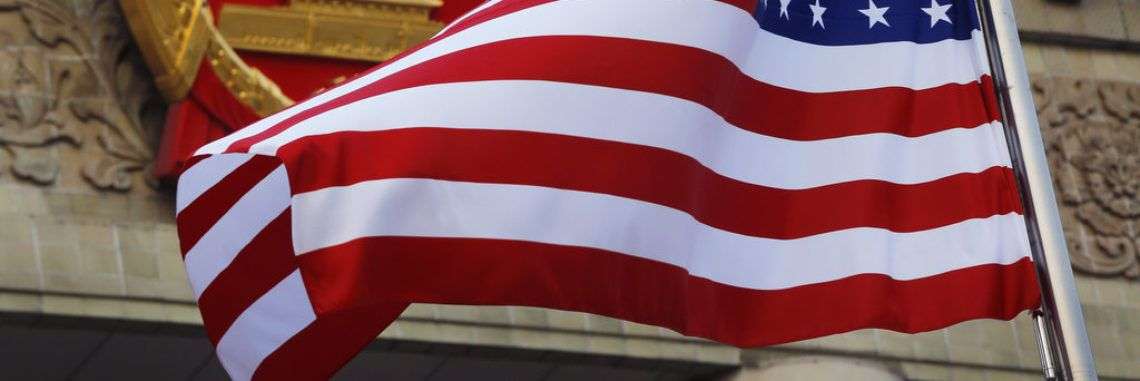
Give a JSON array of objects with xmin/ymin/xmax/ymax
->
[{"xmin": 185, "ymin": 165, "xmax": 290, "ymax": 297}]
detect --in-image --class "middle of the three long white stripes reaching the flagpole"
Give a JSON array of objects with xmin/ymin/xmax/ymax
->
[{"xmin": 251, "ymin": 81, "xmax": 1010, "ymax": 189}]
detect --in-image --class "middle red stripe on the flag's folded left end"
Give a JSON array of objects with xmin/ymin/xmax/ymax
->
[{"xmin": 198, "ymin": 210, "xmax": 296, "ymax": 344}]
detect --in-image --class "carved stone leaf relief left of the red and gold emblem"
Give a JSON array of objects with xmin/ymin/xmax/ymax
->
[{"xmin": 0, "ymin": 0, "xmax": 162, "ymax": 192}]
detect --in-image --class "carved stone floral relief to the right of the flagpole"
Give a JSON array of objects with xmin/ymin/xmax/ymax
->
[{"xmin": 1034, "ymin": 78, "xmax": 1140, "ymax": 278}]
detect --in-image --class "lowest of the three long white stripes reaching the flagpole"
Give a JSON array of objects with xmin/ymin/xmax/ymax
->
[{"xmin": 293, "ymin": 179, "xmax": 1029, "ymax": 290}]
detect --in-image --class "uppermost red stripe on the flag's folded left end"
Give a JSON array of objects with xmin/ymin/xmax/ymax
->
[{"xmin": 176, "ymin": 156, "xmax": 280, "ymax": 258}]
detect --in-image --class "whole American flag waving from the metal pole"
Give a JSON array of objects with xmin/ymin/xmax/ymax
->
[{"xmin": 177, "ymin": 0, "xmax": 1039, "ymax": 380}]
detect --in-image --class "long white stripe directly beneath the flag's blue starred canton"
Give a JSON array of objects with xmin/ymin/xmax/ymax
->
[{"xmin": 198, "ymin": 0, "xmax": 986, "ymax": 153}]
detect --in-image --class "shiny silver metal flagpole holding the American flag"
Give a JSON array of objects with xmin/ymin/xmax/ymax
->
[{"xmin": 977, "ymin": 0, "xmax": 1097, "ymax": 381}]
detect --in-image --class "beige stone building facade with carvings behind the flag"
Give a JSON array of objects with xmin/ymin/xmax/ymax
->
[{"xmin": 0, "ymin": 0, "xmax": 1140, "ymax": 381}]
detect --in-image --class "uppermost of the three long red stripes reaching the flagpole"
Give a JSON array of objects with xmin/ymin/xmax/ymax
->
[{"xmin": 230, "ymin": 37, "xmax": 998, "ymax": 152}]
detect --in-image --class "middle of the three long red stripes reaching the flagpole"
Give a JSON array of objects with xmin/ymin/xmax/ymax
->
[{"xmin": 279, "ymin": 128, "xmax": 1021, "ymax": 238}]
